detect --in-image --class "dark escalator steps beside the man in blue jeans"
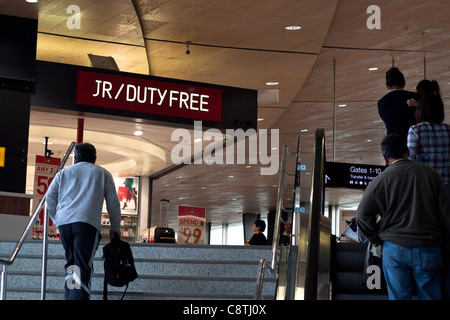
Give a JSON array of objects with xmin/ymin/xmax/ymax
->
[{"xmin": 333, "ymin": 242, "xmax": 388, "ymax": 300}]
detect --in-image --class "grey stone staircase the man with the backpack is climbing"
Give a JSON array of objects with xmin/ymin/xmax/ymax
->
[{"xmin": 0, "ymin": 240, "xmax": 276, "ymax": 300}]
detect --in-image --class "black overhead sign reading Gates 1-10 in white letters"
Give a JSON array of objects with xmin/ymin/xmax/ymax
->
[{"xmin": 325, "ymin": 162, "xmax": 386, "ymax": 189}]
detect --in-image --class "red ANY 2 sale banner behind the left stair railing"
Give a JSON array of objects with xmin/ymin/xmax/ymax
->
[{"xmin": 32, "ymin": 156, "xmax": 61, "ymax": 239}]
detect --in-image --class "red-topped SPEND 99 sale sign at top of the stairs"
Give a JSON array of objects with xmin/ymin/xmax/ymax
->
[{"xmin": 178, "ymin": 206, "xmax": 206, "ymax": 244}]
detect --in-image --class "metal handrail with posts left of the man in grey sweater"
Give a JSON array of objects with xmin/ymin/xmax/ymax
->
[{"xmin": 0, "ymin": 142, "xmax": 76, "ymax": 300}]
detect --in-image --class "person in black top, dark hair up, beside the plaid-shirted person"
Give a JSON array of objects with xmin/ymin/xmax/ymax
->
[{"xmin": 378, "ymin": 67, "xmax": 419, "ymax": 142}]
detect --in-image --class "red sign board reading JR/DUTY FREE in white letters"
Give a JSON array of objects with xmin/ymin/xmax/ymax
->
[{"xmin": 75, "ymin": 71, "xmax": 222, "ymax": 121}]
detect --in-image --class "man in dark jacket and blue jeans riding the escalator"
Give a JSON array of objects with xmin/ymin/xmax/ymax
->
[{"xmin": 356, "ymin": 134, "xmax": 450, "ymax": 300}]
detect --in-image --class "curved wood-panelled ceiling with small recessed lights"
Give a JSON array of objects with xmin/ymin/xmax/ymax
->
[{"xmin": 0, "ymin": 0, "xmax": 450, "ymax": 223}]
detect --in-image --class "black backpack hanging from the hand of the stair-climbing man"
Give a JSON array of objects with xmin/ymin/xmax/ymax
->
[{"xmin": 103, "ymin": 239, "xmax": 138, "ymax": 300}]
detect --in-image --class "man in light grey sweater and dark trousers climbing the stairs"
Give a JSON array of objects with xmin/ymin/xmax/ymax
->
[{"xmin": 46, "ymin": 143, "xmax": 120, "ymax": 300}]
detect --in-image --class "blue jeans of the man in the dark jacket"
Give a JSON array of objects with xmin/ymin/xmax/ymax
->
[{"xmin": 383, "ymin": 241, "xmax": 442, "ymax": 300}]
